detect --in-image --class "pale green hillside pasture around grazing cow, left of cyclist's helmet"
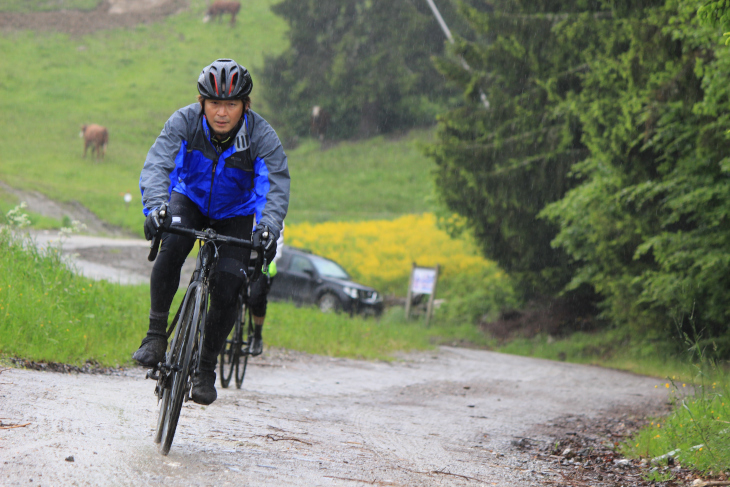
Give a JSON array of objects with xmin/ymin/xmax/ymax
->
[{"xmin": 0, "ymin": 0, "xmax": 287, "ymax": 236}]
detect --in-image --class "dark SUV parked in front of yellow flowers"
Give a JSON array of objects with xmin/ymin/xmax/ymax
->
[{"xmin": 269, "ymin": 246, "xmax": 383, "ymax": 316}]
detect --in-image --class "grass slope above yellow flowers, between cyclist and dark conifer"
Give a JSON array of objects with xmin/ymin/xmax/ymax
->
[{"xmin": 287, "ymin": 134, "xmax": 435, "ymax": 223}]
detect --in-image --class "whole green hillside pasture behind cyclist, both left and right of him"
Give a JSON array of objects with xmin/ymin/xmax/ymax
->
[{"xmin": 0, "ymin": 0, "xmax": 433, "ymax": 235}]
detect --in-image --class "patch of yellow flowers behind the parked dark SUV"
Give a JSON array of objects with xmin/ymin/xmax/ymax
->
[{"xmin": 285, "ymin": 213, "xmax": 513, "ymax": 324}]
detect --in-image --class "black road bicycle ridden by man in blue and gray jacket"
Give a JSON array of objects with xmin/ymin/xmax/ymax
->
[{"xmin": 147, "ymin": 206, "xmax": 267, "ymax": 455}]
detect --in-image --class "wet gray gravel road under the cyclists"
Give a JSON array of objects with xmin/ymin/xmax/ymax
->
[{"xmin": 0, "ymin": 347, "xmax": 666, "ymax": 487}]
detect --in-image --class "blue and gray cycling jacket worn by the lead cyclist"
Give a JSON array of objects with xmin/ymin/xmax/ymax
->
[{"xmin": 139, "ymin": 103, "xmax": 290, "ymax": 235}]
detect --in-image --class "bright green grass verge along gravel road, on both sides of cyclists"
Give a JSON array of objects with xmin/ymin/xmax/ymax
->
[{"xmin": 0, "ymin": 215, "xmax": 486, "ymax": 366}]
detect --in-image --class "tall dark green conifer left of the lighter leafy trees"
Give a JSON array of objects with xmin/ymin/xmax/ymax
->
[{"xmin": 429, "ymin": 0, "xmax": 610, "ymax": 297}]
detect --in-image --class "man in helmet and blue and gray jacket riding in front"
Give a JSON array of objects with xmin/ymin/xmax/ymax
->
[{"xmin": 133, "ymin": 59, "xmax": 290, "ymax": 405}]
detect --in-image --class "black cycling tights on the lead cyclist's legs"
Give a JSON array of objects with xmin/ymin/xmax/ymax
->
[{"xmin": 150, "ymin": 192, "xmax": 253, "ymax": 368}]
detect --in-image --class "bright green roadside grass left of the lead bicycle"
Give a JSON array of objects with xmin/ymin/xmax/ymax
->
[{"xmin": 0, "ymin": 221, "xmax": 149, "ymax": 365}]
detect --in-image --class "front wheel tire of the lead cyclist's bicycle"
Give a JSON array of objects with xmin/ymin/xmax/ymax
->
[{"xmin": 160, "ymin": 286, "xmax": 204, "ymax": 455}]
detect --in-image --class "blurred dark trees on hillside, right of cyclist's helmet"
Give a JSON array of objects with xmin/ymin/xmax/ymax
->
[{"xmin": 263, "ymin": 0, "xmax": 463, "ymax": 139}]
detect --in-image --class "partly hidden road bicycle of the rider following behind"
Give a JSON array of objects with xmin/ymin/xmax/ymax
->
[{"xmin": 219, "ymin": 267, "xmax": 258, "ymax": 389}]
